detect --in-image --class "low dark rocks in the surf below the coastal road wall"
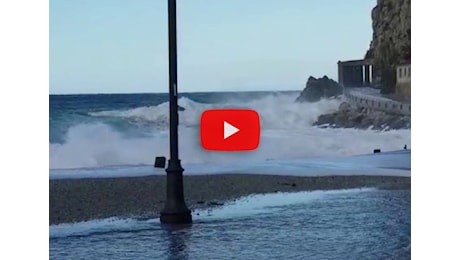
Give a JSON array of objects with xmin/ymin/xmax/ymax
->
[{"xmin": 314, "ymin": 102, "xmax": 410, "ymax": 130}]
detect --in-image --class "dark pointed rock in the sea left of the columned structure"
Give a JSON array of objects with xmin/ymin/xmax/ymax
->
[{"xmin": 296, "ymin": 76, "xmax": 343, "ymax": 102}]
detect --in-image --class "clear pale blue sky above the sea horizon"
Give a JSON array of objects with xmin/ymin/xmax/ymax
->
[{"xmin": 50, "ymin": 0, "xmax": 376, "ymax": 94}]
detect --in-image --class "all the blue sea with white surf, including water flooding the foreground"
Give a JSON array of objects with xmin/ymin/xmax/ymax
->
[{"xmin": 49, "ymin": 91, "xmax": 411, "ymax": 259}]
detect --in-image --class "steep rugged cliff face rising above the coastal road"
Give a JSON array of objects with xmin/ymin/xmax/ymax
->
[{"xmin": 365, "ymin": 0, "xmax": 411, "ymax": 92}]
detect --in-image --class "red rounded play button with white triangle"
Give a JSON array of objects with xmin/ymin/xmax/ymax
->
[{"xmin": 200, "ymin": 109, "xmax": 260, "ymax": 151}]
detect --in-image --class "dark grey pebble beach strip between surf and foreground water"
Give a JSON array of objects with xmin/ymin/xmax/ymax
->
[{"xmin": 49, "ymin": 174, "xmax": 411, "ymax": 225}]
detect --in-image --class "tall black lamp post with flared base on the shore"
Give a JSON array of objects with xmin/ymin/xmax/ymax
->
[{"xmin": 160, "ymin": 0, "xmax": 192, "ymax": 224}]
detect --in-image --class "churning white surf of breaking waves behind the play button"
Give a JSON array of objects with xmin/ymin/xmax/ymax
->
[{"xmin": 49, "ymin": 94, "xmax": 410, "ymax": 169}]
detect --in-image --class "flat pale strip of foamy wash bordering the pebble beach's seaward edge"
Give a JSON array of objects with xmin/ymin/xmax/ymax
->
[{"xmin": 49, "ymin": 150, "xmax": 411, "ymax": 179}]
